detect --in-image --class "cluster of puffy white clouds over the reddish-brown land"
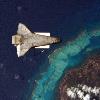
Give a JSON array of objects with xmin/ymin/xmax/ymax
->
[{"xmin": 66, "ymin": 84, "xmax": 100, "ymax": 100}]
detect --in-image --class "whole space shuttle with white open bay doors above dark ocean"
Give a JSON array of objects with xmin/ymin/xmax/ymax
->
[{"xmin": 12, "ymin": 23, "xmax": 60, "ymax": 57}]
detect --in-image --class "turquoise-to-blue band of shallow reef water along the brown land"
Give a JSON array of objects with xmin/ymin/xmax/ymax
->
[{"xmin": 31, "ymin": 27, "xmax": 100, "ymax": 100}]
